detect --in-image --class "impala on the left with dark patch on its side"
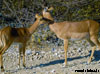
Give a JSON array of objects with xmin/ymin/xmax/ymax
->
[{"xmin": 0, "ymin": 14, "xmax": 47, "ymax": 71}]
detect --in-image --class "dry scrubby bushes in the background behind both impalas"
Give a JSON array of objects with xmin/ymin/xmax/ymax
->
[{"xmin": 0, "ymin": 0, "xmax": 100, "ymax": 45}]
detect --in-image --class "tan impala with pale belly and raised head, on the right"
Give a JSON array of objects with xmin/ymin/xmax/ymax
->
[{"xmin": 42, "ymin": 7, "xmax": 100, "ymax": 66}]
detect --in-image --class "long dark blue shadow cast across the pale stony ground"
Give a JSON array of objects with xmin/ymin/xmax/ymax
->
[{"xmin": 5, "ymin": 50, "xmax": 100, "ymax": 73}]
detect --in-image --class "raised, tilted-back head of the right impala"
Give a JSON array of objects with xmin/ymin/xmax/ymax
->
[{"xmin": 42, "ymin": 7, "xmax": 54, "ymax": 21}]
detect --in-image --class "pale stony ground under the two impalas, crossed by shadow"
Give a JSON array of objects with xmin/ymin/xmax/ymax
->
[{"xmin": 0, "ymin": 40, "xmax": 100, "ymax": 74}]
